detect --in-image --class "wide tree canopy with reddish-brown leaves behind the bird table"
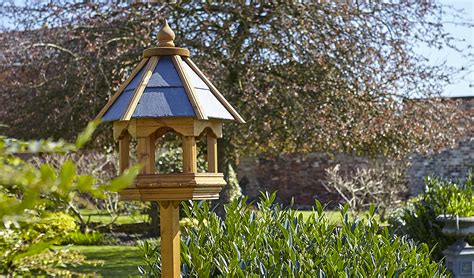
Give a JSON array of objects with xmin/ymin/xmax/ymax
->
[{"xmin": 0, "ymin": 1, "xmax": 472, "ymax": 158}]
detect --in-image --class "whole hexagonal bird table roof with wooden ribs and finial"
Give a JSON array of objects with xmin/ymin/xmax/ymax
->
[{"xmin": 97, "ymin": 20, "xmax": 245, "ymax": 123}]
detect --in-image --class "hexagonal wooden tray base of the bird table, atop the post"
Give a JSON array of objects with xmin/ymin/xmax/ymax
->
[{"xmin": 120, "ymin": 173, "xmax": 226, "ymax": 201}]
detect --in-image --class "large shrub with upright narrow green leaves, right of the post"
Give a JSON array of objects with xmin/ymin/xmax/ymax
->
[{"xmin": 141, "ymin": 194, "xmax": 445, "ymax": 277}]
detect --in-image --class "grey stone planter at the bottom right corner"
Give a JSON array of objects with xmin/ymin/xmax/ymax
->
[{"xmin": 437, "ymin": 215, "xmax": 474, "ymax": 277}]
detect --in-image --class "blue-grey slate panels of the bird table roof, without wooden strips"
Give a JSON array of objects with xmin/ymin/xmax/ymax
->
[{"xmin": 102, "ymin": 56, "xmax": 241, "ymax": 121}]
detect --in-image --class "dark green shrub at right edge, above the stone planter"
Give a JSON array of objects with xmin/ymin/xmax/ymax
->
[{"xmin": 389, "ymin": 176, "xmax": 474, "ymax": 260}]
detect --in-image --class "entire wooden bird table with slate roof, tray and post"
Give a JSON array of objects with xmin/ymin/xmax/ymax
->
[{"xmin": 97, "ymin": 20, "xmax": 244, "ymax": 277}]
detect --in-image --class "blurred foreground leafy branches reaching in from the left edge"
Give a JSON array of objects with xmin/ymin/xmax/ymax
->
[{"xmin": 0, "ymin": 122, "xmax": 139, "ymax": 223}]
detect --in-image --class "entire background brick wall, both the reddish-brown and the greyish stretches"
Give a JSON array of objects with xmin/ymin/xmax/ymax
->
[{"xmin": 237, "ymin": 97, "xmax": 474, "ymax": 208}]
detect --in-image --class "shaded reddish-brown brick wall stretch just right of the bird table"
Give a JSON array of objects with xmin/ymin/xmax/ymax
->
[{"xmin": 237, "ymin": 153, "xmax": 367, "ymax": 208}]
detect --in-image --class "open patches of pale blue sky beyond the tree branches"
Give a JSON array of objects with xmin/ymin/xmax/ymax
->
[{"xmin": 0, "ymin": 0, "xmax": 474, "ymax": 97}]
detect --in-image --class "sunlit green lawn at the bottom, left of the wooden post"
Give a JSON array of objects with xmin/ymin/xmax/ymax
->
[{"xmin": 63, "ymin": 246, "xmax": 142, "ymax": 277}]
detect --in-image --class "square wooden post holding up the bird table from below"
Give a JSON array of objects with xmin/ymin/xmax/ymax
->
[{"xmin": 160, "ymin": 201, "xmax": 181, "ymax": 278}]
